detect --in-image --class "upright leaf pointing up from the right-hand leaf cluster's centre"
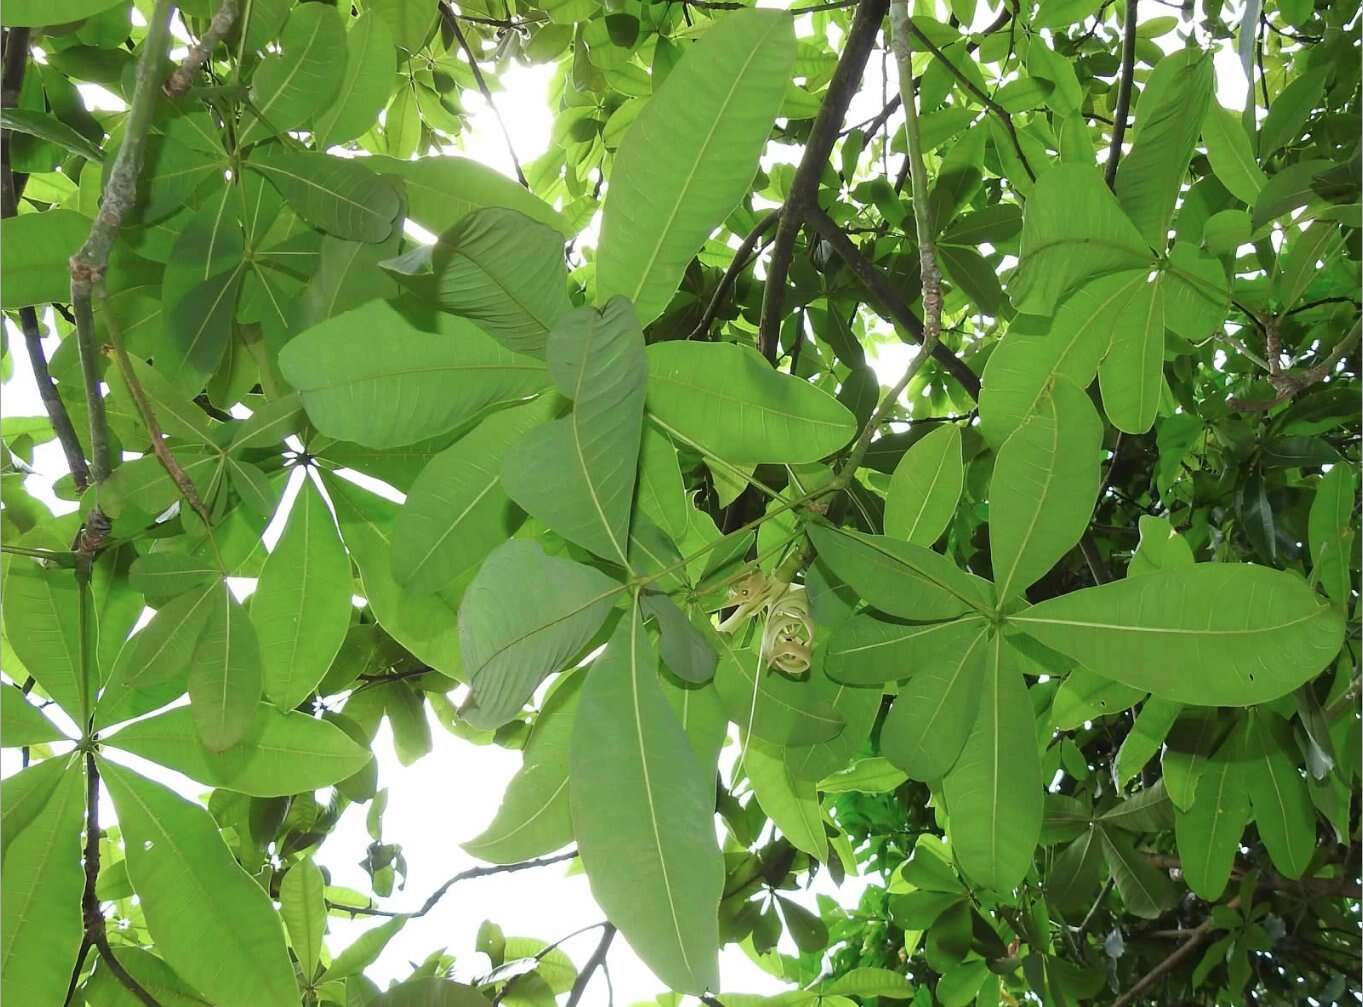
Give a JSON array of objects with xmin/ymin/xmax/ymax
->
[{"xmin": 990, "ymin": 376, "xmax": 1106, "ymax": 600}]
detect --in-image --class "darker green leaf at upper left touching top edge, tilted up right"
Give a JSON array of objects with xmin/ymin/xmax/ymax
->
[{"xmin": 240, "ymin": 4, "xmax": 346, "ymax": 144}]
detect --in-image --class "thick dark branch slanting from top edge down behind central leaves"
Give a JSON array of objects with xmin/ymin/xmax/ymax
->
[{"xmin": 758, "ymin": 0, "xmax": 889, "ymax": 364}]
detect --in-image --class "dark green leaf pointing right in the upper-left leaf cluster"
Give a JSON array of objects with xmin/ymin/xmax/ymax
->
[{"xmin": 245, "ymin": 146, "xmax": 399, "ymax": 243}]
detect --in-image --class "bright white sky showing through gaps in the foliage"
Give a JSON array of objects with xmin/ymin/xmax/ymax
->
[{"xmin": 0, "ymin": 0, "xmax": 1246, "ymax": 1007}]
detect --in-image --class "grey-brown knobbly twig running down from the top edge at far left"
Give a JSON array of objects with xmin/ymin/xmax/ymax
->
[{"xmin": 71, "ymin": 0, "xmax": 174, "ymax": 484}]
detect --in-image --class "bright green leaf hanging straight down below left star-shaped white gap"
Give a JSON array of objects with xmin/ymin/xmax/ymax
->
[{"xmin": 251, "ymin": 478, "xmax": 354, "ymax": 710}]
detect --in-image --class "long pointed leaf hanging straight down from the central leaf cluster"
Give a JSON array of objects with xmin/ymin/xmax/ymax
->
[{"xmin": 568, "ymin": 608, "xmax": 724, "ymax": 993}]
